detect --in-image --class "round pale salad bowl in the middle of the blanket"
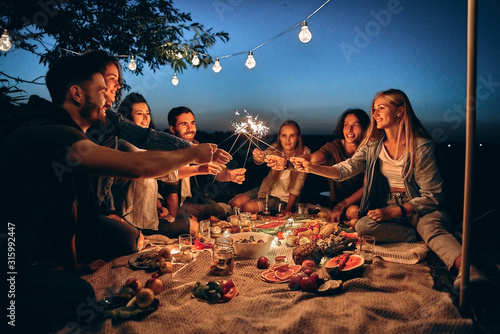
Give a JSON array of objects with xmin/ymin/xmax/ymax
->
[{"xmin": 230, "ymin": 232, "xmax": 274, "ymax": 259}]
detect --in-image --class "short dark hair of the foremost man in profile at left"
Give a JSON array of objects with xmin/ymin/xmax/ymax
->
[{"xmin": 45, "ymin": 56, "xmax": 103, "ymax": 105}]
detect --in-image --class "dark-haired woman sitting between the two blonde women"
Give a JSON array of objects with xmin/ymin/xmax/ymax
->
[{"xmin": 309, "ymin": 109, "xmax": 370, "ymax": 222}]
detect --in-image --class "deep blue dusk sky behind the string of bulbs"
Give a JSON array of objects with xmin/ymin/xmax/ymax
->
[{"xmin": 0, "ymin": 0, "xmax": 500, "ymax": 142}]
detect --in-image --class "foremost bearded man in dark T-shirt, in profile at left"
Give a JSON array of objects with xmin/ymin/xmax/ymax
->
[{"xmin": 0, "ymin": 56, "xmax": 221, "ymax": 333}]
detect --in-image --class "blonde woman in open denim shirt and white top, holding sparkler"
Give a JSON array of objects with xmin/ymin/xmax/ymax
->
[{"xmin": 291, "ymin": 89, "xmax": 468, "ymax": 285}]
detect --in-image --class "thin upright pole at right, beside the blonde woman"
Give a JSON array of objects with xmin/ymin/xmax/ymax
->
[{"xmin": 460, "ymin": 0, "xmax": 477, "ymax": 313}]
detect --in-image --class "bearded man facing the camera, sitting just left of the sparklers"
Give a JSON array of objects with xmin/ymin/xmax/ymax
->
[{"xmin": 160, "ymin": 107, "xmax": 246, "ymax": 224}]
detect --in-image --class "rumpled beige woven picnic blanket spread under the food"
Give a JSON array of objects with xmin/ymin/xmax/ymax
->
[{"xmin": 82, "ymin": 240, "xmax": 473, "ymax": 333}]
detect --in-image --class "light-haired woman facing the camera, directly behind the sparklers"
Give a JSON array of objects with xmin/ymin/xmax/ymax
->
[{"xmin": 229, "ymin": 120, "xmax": 311, "ymax": 213}]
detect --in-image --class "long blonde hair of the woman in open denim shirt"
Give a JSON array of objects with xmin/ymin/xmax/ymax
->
[{"xmin": 361, "ymin": 89, "xmax": 430, "ymax": 180}]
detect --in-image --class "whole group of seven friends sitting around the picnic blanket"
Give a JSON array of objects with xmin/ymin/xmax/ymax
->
[{"xmin": 0, "ymin": 51, "xmax": 482, "ymax": 332}]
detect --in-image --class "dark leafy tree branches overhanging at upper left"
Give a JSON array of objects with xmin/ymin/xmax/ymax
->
[{"xmin": 0, "ymin": 0, "xmax": 229, "ymax": 74}]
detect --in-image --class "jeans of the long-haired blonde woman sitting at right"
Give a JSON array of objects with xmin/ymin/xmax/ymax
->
[{"xmin": 356, "ymin": 193, "xmax": 462, "ymax": 269}]
